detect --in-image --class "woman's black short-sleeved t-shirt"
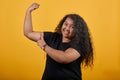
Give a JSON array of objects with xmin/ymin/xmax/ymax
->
[{"xmin": 42, "ymin": 32, "xmax": 82, "ymax": 80}]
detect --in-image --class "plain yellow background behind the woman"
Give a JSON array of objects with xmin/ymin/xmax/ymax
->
[{"xmin": 0, "ymin": 0, "xmax": 120, "ymax": 80}]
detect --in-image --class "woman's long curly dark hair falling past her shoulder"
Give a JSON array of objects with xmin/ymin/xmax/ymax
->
[{"xmin": 55, "ymin": 14, "xmax": 93, "ymax": 67}]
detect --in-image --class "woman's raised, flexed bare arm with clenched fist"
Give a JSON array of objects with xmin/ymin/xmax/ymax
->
[{"xmin": 24, "ymin": 3, "xmax": 42, "ymax": 41}]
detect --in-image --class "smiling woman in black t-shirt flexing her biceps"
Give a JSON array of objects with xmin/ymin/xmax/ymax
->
[{"xmin": 24, "ymin": 3, "xmax": 93, "ymax": 80}]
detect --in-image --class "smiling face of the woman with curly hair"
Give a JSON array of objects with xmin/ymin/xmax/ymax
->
[{"xmin": 61, "ymin": 17, "xmax": 75, "ymax": 40}]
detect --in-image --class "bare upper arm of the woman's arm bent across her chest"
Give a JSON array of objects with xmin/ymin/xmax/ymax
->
[{"xmin": 63, "ymin": 48, "xmax": 81, "ymax": 63}]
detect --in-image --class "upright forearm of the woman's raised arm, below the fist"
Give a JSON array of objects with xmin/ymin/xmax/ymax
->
[{"xmin": 24, "ymin": 10, "xmax": 33, "ymax": 36}]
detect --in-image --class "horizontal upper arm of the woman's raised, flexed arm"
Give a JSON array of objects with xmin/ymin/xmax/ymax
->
[{"xmin": 25, "ymin": 32, "xmax": 43, "ymax": 42}]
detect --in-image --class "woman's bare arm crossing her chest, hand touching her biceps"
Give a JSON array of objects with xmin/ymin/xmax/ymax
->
[{"xmin": 38, "ymin": 34, "xmax": 80, "ymax": 64}]
